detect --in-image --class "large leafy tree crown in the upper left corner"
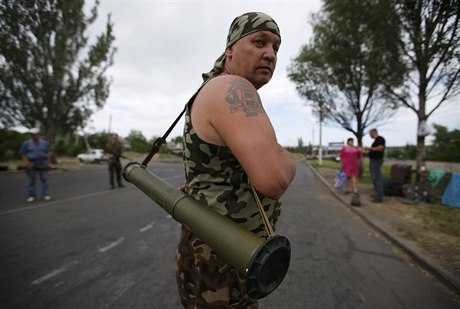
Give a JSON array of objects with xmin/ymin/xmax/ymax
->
[{"xmin": 0, "ymin": 0, "xmax": 115, "ymax": 144}]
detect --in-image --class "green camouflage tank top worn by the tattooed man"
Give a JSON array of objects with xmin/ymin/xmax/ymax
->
[{"xmin": 183, "ymin": 104, "xmax": 281, "ymax": 237}]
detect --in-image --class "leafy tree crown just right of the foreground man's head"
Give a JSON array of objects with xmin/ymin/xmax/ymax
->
[{"xmin": 288, "ymin": 0, "xmax": 406, "ymax": 145}]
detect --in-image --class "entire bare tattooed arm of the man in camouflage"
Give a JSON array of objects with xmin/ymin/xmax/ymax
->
[{"xmin": 192, "ymin": 75, "xmax": 295, "ymax": 198}]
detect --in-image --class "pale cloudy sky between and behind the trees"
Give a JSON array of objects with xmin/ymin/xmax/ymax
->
[{"xmin": 77, "ymin": 0, "xmax": 460, "ymax": 146}]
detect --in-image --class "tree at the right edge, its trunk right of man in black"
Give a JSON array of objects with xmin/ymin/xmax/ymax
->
[{"xmin": 391, "ymin": 0, "xmax": 460, "ymax": 171}]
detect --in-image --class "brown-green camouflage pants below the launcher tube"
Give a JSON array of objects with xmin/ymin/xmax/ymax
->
[{"xmin": 176, "ymin": 227, "xmax": 258, "ymax": 309}]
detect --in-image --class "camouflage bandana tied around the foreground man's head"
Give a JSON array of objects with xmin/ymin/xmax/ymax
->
[{"xmin": 202, "ymin": 12, "xmax": 281, "ymax": 82}]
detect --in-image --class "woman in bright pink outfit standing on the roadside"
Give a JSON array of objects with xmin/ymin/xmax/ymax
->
[{"xmin": 339, "ymin": 138, "xmax": 363, "ymax": 195}]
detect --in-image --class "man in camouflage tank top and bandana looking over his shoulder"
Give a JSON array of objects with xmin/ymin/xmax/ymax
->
[{"xmin": 176, "ymin": 13, "xmax": 295, "ymax": 308}]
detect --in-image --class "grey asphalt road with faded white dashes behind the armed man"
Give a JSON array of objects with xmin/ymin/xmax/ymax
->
[{"xmin": 0, "ymin": 162, "xmax": 459, "ymax": 309}]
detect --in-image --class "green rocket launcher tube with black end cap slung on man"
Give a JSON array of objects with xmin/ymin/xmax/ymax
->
[{"xmin": 123, "ymin": 162, "xmax": 291, "ymax": 299}]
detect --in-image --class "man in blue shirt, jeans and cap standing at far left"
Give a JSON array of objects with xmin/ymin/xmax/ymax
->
[{"xmin": 19, "ymin": 128, "xmax": 52, "ymax": 203}]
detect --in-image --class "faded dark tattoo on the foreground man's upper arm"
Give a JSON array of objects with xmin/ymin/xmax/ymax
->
[{"xmin": 225, "ymin": 80, "xmax": 265, "ymax": 117}]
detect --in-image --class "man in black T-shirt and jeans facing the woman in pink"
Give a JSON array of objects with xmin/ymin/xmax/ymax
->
[{"xmin": 365, "ymin": 129, "xmax": 385, "ymax": 203}]
